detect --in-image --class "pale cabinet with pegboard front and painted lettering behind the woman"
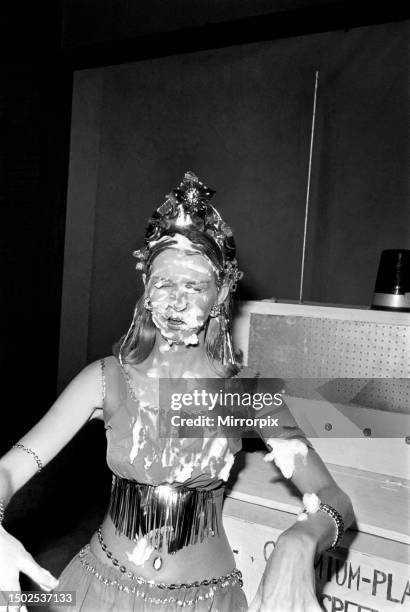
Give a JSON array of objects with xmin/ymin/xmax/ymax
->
[{"xmin": 224, "ymin": 302, "xmax": 410, "ymax": 612}]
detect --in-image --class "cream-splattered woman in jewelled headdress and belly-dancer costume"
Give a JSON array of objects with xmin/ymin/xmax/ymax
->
[{"xmin": 0, "ymin": 172, "xmax": 352, "ymax": 612}]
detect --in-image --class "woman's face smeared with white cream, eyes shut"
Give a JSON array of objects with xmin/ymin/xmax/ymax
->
[{"xmin": 146, "ymin": 248, "xmax": 218, "ymax": 345}]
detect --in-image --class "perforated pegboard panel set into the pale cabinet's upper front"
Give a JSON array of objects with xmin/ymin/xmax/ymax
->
[{"xmin": 249, "ymin": 314, "xmax": 410, "ymax": 378}]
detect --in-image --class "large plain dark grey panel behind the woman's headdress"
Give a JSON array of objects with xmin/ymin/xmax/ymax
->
[{"xmin": 60, "ymin": 23, "xmax": 410, "ymax": 384}]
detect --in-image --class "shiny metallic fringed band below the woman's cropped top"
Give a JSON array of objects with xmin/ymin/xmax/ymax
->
[{"xmin": 108, "ymin": 474, "xmax": 224, "ymax": 553}]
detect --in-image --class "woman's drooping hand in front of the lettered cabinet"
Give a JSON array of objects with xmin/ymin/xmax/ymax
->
[{"xmin": 248, "ymin": 529, "xmax": 322, "ymax": 612}]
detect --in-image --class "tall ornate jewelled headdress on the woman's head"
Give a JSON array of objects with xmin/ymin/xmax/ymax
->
[{"xmin": 133, "ymin": 171, "xmax": 243, "ymax": 291}]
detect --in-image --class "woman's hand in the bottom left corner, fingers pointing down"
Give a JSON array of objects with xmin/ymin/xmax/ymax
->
[{"xmin": 0, "ymin": 525, "xmax": 58, "ymax": 612}]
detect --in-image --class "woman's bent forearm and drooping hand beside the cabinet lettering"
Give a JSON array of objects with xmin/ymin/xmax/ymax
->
[{"xmin": 249, "ymin": 448, "xmax": 354, "ymax": 612}]
